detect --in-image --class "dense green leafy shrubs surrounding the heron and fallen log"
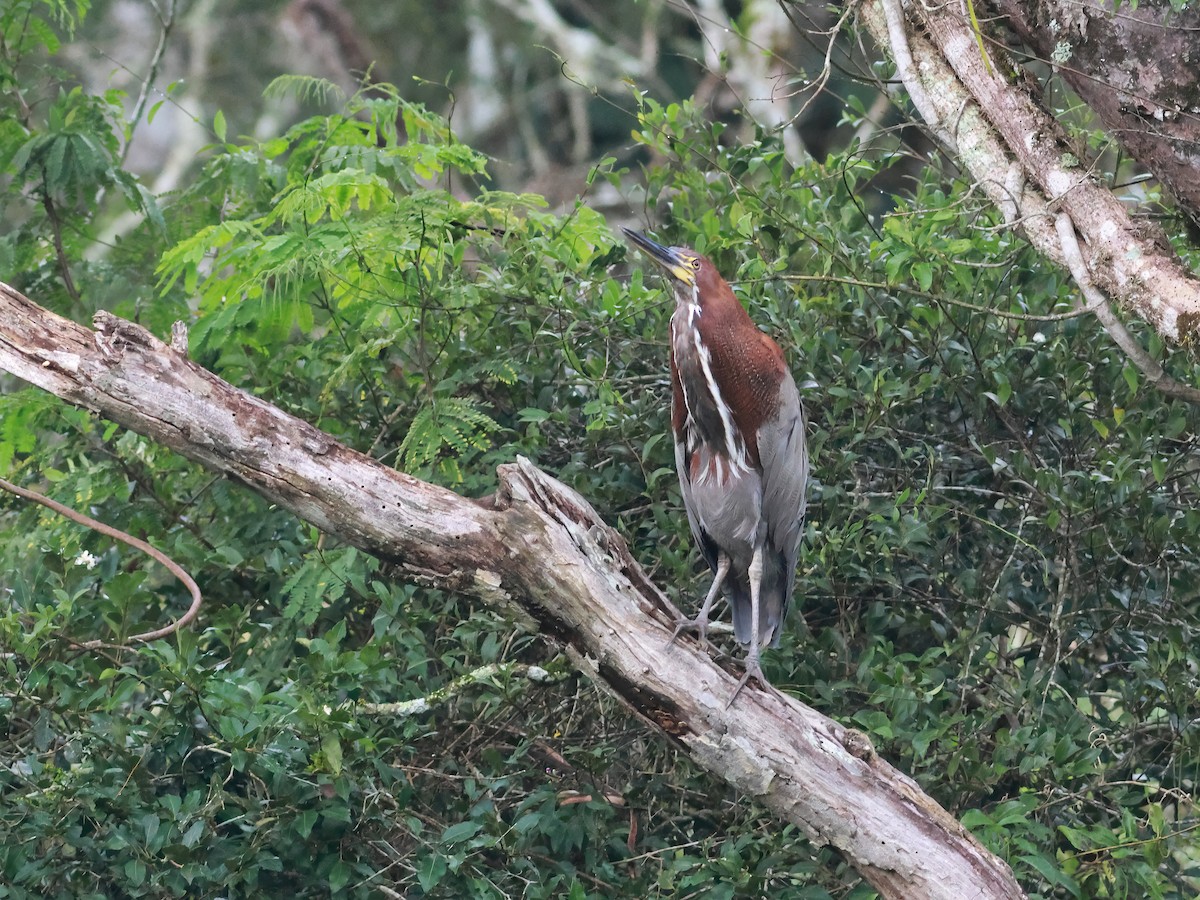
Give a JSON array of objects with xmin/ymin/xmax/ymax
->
[{"xmin": 0, "ymin": 4, "xmax": 1200, "ymax": 898}]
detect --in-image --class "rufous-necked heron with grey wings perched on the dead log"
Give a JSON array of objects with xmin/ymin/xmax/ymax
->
[{"xmin": 623, "ymin": 228, "xmax": 809, "ymax": 703}]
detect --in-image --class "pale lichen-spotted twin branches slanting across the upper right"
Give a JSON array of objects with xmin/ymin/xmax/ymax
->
[{"xmin": 859, "ymin": 0, "xmax": 1200, "ymax": 355}]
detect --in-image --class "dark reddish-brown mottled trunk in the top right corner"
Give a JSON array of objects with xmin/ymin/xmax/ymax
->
[{"xmin": 992, "ymin": 0, "xmax": 1200, "ymax": 223}]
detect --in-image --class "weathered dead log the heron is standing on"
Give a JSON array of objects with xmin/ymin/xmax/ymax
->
[{"xmin": 0, "ymin": 284, "xmax": 1022, "ymax": 900}]
